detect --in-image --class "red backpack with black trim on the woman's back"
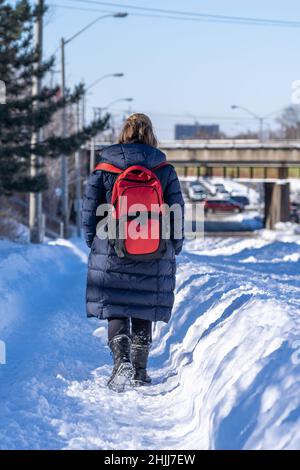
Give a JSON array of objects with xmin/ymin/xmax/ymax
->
[{"xmin": 95, "ymin": 162, "xmax": 170, "ymax": 260}]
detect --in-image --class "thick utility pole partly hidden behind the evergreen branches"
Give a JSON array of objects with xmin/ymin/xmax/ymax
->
[{"xmin": 29, "ymin": 0, "xmax": 44, "ymax": 243}]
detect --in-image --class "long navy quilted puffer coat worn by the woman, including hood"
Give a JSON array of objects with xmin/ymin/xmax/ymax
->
[{"xmin": 82, "ymin": 144, "xmax": 184, "ymax": 322}]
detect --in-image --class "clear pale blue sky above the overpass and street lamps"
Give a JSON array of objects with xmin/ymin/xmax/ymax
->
[{"xmin": 44, "ymin": 0, "xmax": 300, "ymax": 139}]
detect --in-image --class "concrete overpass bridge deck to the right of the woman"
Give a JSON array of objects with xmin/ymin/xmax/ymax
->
[{"xmin": 160, "ymin": 140, "xmax": 300, "ymax": 179}]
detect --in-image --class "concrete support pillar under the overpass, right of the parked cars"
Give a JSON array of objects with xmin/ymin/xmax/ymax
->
[{"xmin": 264, "ymin": 183, "xmax": 290, "ymax": 230}]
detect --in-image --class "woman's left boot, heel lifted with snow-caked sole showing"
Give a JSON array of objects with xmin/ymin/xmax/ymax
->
[{"xmin": 107, "ymin": 335, "xmax": 134, "ymax": 392}]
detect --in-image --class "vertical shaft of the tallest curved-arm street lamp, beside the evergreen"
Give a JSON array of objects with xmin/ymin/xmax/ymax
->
[{"xmin": 60, "ymin": 38, "xmax": 69, "ymax": 238}]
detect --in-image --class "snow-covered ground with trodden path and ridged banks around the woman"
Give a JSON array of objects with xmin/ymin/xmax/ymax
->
[{"xmin": 0, "ymin": 236, "xmax": 300, "ymax": 449}]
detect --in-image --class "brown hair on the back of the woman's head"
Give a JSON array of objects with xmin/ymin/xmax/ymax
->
[{"xmin": 118, "ymin": 113, "xmax": 158, "ymax": 147}]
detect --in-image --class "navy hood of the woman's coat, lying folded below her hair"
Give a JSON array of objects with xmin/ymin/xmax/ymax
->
[{"xmin": 98, "ymin": 144, "xmax": 166, "ymax": 170}]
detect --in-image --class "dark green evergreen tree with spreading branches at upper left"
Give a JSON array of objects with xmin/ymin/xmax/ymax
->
[{"xmin": 0, "ymin": 0, "xmax": 109, "ymax": 195}]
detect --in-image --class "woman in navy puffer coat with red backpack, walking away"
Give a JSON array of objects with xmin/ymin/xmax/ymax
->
[{"xmin": 82, "ymin": 114, "xmax": 184, "ymax": 392}]
